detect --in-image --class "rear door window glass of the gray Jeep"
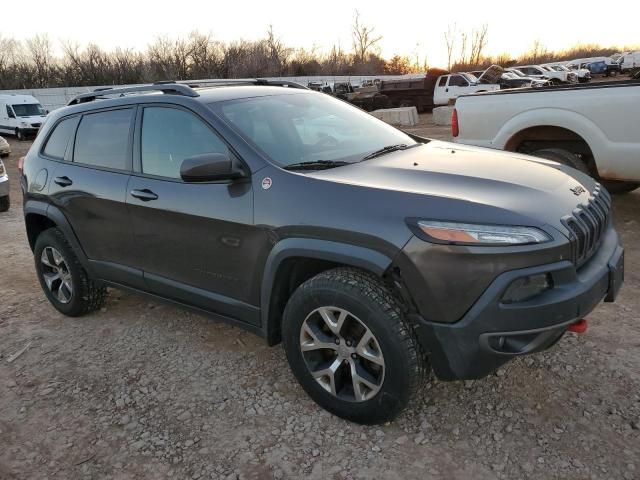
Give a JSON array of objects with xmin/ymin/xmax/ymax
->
[{"xmin": 73, "ymin": 108, "xmax": 133, "ymax": 170}]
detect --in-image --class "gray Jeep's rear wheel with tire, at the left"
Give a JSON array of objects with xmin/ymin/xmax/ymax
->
[{"xmin": 33, "ymin": 228, "xmax": 107, "ymax": 317}]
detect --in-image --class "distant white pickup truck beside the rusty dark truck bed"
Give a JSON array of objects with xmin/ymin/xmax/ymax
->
[{"xmin": 433, "ymin": 65, "xmax": 504, "ymax": 105}]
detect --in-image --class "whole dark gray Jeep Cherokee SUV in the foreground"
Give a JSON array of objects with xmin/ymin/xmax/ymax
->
[{"xmin": 21, "ymin": 81, "xmax": 623, "ymax": 423}]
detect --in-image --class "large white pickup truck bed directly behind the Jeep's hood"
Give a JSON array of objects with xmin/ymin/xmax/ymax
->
[{"xmin": 452, "ymin": 80, "xmax": 640, "ymax": 193}]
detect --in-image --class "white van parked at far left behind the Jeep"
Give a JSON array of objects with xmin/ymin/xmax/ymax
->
[{"xmin": 0, "ymin": 94, "xmax": 48, "ymax": 140}]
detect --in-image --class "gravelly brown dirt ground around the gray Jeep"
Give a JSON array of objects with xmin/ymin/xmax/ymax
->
[{"xmin": 0, "ymin": 125, "xmax": 640, "ymax": 480}]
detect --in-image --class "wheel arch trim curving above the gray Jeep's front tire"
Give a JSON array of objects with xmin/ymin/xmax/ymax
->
[{"xmin": 260, "ymin": 238, "xmax": 392, "ymax": 345}]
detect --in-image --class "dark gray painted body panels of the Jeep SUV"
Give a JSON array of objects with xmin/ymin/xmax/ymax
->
[{"xmin": 25, "ymin": 86, "xmax": 616, "ymax": 344}]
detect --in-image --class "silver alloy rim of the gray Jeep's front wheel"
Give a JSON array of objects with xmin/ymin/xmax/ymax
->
[{"xmin": 300, "ymin": 307, "xmax": 385, "ymax": 402}]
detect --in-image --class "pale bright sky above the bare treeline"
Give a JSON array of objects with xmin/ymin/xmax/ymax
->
[{"xmin": 0, "ymin": 0, "xmax": 640, "ymax": 66}]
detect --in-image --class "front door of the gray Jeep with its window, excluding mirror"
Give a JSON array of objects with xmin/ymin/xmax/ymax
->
[{"xmin": 127, "ymin": 106, "xmax": 265, "ymax": 323}]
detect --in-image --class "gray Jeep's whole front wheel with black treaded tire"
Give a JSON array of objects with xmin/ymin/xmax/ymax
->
[{"xmin": 282, "ymin": 268, "xmax": 429, "ymax": 424}]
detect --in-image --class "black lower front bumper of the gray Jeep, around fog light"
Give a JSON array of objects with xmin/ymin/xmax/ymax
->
[{"xmin": 413, "ymin": 228, "xmax": 624, "ymax": 380}]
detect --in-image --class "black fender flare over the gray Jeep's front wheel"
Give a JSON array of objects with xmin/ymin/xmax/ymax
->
[{"xmin": 260, "ymin": 238, "xmax": 392, "ymax": 343}]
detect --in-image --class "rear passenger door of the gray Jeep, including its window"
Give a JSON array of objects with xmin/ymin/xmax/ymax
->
[{"xmin": 43, "ymin": 107, "xmax": 142, "ymax": 286}]
